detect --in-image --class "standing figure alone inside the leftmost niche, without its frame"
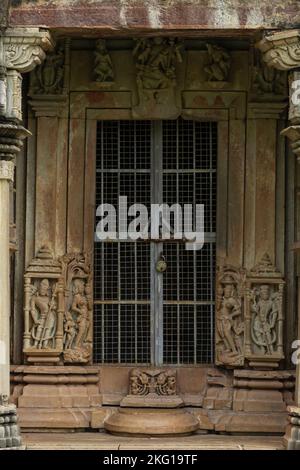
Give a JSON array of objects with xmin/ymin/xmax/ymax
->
[{"xmin": 30, "ymin": 279, "xmax": 57, "ymax": 349}]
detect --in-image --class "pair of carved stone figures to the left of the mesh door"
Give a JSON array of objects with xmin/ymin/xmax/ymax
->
[{"xmin": 24, "ymin": 247, "xmax": 92, "ymax": 362}]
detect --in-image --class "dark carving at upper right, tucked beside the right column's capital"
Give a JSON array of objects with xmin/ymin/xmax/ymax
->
[{"xmin": 253, "ymin": 54, "xmax": 287, "ymax": 96}]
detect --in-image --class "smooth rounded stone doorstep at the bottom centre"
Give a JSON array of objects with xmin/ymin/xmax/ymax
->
[{"xmin": 104, "ymin": 408, "xmax": 199, "ymax": 436}]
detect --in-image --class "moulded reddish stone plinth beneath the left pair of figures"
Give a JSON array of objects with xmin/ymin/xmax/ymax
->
[{"xmin": 11, "ymin": 366, "xmax": 101, "ymax": 430}]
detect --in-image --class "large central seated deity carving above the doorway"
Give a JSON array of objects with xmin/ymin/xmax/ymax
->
[{"xmin": 133, "ymin": 37, "xmax": 182, "ymax": 90}]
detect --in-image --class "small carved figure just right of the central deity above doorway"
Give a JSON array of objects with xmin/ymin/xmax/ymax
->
[{"xmin": 204, "ymin": 44, "xmax": 231, "ymax": 82}]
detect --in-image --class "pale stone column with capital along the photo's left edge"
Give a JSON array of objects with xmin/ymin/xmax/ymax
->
[{"xmin": 0, "ymin": 28, "xmax": 53, "ymax": 449}]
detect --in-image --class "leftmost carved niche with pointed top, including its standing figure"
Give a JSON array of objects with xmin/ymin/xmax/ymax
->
[{"xmin": 24, "ymin": 246, "xmax": 64, "ymax": 362}]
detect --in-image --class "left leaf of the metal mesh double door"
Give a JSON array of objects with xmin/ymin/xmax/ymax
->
[{"xmin": 94, "ymin": 121, "xmax": 152, "ymax": 364}]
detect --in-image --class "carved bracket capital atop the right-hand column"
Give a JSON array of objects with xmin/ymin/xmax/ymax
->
[{"xmin": 256, "ymin": 29, "xmax": 300, "ymax": 70}]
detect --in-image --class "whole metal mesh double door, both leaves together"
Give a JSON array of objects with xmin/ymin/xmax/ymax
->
[{"xmin": 94, "ymin": 119, "xmax": 217, "ymax": 365}]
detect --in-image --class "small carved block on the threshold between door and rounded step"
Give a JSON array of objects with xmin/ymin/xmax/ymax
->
[{"xmin": 130, "ymin": 369, "xmax": 176, "ymax": 396}]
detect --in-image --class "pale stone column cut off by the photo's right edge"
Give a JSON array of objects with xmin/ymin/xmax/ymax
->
[{"xmin": 257, "ymin": 30, "xmax": 300, "ymax": 450}]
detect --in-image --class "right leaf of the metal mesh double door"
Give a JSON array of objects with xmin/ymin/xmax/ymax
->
[{"xmin": 162, "ymin": 119, "xmax": 217, "ymax": 364}]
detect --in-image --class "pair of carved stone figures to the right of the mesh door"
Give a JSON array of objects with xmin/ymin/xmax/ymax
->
[{"xmin": 216, "ymin": 255, "xmax": 284, "ymax": 366}]
